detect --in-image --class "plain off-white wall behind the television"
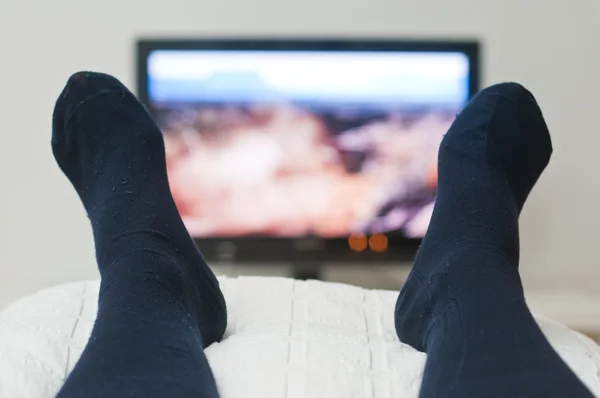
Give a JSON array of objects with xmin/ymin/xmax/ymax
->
[{"xmin": 0, "ymin": 0, "xmax": 600, "ymax": 307}]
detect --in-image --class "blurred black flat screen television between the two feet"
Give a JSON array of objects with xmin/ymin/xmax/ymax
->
[{"xmin": 137, "ymin": 39, "xmax": 479, "ymax": 264}]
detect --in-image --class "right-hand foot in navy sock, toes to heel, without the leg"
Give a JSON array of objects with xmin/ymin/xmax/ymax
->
[{"xmin": 396, "ymin": 83, "xmax": 552, "ymax": 351}]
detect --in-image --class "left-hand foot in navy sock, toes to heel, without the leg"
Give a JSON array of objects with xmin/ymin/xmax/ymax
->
[{"xmin": 52, "ymin": 72, "xmax": 227, "ymax": 346}]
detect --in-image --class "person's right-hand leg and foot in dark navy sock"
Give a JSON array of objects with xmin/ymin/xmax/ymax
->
[{"xmin": 395, "ymin": 83, "xmax": 592, "ymax": 398}]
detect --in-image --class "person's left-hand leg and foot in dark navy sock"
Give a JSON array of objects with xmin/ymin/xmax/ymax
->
[{"xmin": 52, "ymin": 72, "xmax": 227, "ymax": 398}]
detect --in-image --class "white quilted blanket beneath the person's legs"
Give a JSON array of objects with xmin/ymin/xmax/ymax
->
[{"xmin": 0, "ymin": 277, "xmax": 600, "ymax": 398}]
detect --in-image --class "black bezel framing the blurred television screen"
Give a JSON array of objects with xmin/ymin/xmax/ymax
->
[{"xmin": 136, "ymin": 38, "xmax": 480, "ymax": 264}]
